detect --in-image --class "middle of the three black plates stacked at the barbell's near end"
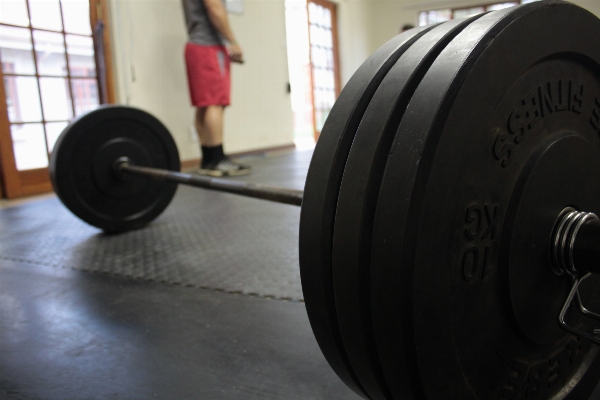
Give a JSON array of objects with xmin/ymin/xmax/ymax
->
[{"xmin": 332, "ymin": 16, "xmax": 488, "ymax": 399}]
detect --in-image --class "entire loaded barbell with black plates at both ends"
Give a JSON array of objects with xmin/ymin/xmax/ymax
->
[{"xmin": 50, "ymin": 0, "xmax": 600, "ymax": 400}]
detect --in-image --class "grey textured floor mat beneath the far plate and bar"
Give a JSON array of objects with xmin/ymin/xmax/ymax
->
[{"xmin": 0, "ymin": 151, "xmax": 312, "ymax": 301}]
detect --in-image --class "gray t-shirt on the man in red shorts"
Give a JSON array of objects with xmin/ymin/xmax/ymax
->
[{"xmin": 182, "ymin": 0, "xmax": 225, "ymax": 46}]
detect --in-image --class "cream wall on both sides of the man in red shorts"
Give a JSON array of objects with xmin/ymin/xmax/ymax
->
[{"xmin": 110, "ymin": 0, "xmax": 293, "ymax": 160}]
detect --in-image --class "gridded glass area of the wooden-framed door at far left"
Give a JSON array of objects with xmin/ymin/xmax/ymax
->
[{"xmin": 0, "ymin": 0, "xmax": 100, "ymax": 196}]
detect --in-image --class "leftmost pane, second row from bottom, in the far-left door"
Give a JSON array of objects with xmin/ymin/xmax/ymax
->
[{"xmin": 4, "ymin": 76, "xmax": 42, "ymax": 122}]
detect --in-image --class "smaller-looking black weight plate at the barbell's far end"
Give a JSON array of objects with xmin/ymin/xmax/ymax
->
[{"xmin": 50, "ymin": 106, "xmax": 180, "ymax": 232}]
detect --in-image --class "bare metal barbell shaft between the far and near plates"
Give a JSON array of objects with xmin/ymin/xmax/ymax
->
[{"xmin": 117, "ymin": 161, "xmax": 303, "ymax": 206}]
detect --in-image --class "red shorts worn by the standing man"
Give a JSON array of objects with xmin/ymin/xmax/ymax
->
[{"xmin": 185, "ymin": 43, "xmax": 231, "ymax": 107}]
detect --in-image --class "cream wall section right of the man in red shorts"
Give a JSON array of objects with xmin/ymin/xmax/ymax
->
[{"xmin": 225, "ymin": 0, "xmax": 294, "ymax": 152}]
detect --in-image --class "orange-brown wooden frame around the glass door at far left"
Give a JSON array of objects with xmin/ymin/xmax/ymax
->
[{"xmin": 0, "ymin": 0, "xmax": 115, "ymax": 198}]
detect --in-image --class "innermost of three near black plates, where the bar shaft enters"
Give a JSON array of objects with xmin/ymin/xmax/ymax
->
[{"xmin": 299, "ymin": 26, "xmax": 432, "ymax": 397}]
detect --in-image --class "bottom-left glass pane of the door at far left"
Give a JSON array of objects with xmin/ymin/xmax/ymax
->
[{"xmin": 10, "ymin": 124, "xmax": 48, "ymax": 171}]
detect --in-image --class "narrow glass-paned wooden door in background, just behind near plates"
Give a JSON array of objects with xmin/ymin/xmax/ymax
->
[{"xmin": 308, "ymin": 0, "xmax": 340, "ymax": 138}]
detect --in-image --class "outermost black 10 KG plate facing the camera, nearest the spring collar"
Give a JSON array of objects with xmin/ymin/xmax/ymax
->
[{"xmin": 370, "ymin": 1, "xmax": 600, "ymax": 399}]
